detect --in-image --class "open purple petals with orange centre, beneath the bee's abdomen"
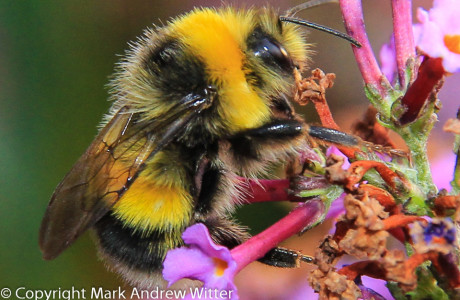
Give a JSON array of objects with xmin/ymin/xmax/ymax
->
[{"xmin": 163, "ymin": 223, "xmax": 238, "ymax": 299}]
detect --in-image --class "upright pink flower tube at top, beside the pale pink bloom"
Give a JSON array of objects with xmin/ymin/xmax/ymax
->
[{"xmin": 391, "ymin": 0, "xmax": 415, "ymax": 87}]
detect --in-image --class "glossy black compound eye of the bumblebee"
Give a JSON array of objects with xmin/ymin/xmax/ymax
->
[{"xmin": 254, "ymin": 37, "xmax": 293, "ymax": 71}]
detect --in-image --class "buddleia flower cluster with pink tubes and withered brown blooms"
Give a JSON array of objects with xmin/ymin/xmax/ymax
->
[{"xmin": 159, "ymin": 0, "xmax": 460, "ymax": 299}]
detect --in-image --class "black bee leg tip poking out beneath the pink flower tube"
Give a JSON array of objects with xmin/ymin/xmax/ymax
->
[{"xmin": 259, "ymin": 247, "xmax": 313, "ymax": 268}]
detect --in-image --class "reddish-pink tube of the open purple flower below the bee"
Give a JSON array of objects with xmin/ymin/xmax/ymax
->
[{"xmin": 231, "ymin": 200, "xmax": 325, "ymax": 272}]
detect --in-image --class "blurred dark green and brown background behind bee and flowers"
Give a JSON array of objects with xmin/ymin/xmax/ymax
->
[{"xmin": 0, "ymin": 0, "xmax": 458, "ymax": 299}]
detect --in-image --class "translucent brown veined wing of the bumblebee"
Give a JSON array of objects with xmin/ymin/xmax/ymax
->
[{"xmin": 39, "ymin": 94, "xmax": 212, "ymax": 259}]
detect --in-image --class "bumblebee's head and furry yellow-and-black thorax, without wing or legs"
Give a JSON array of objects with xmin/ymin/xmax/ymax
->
[{"xmin": 114, "ymin": 7, "xmax": 309, "ymax": 135}]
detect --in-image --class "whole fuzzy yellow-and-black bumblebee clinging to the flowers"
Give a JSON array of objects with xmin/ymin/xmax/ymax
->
[{"xmin": 39, "ymin": 8, "xmax": 358, "ymax": 288}]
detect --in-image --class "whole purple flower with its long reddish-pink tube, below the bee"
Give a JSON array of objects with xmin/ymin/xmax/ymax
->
[{"xmin": 163, "ymin": 200, "xmax": 324, "ymax": 300}]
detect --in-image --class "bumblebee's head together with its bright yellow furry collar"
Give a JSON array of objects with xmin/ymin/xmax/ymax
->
[{"xmin": 167, "ymin": 8, "xmax": 308, "ymax": 134}]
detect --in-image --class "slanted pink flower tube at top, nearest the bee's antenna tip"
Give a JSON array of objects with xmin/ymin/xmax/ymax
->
[{"xmin": 340, "ymin": 0, "xmax": 390, "ymax": 97}]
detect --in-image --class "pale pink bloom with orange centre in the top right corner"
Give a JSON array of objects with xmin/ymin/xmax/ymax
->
[{"xmin": 414, "ymin": 0, "xmax": 460, "ymax": 73}]
